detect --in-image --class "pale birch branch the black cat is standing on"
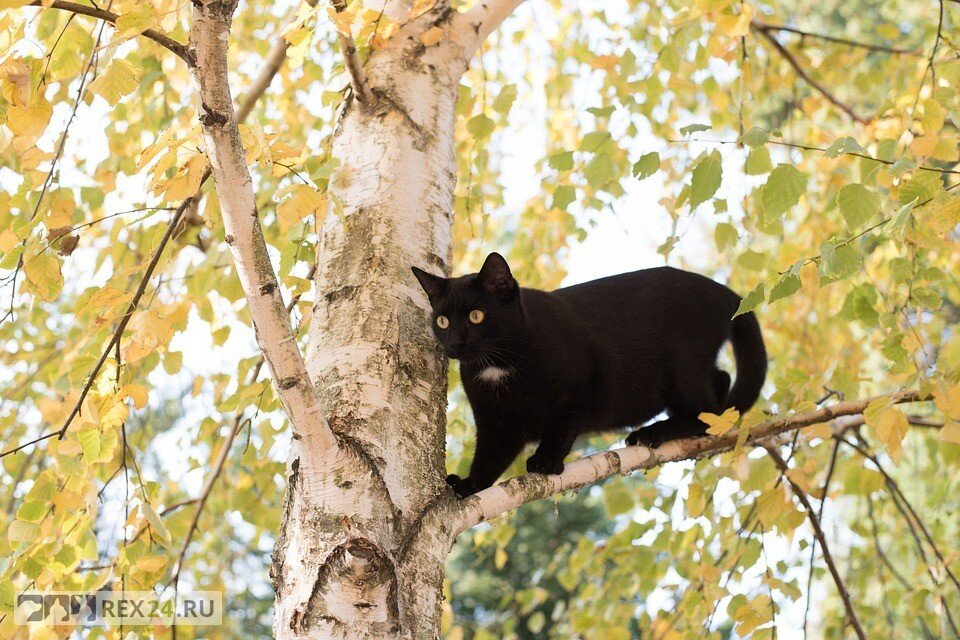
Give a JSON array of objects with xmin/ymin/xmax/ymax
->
[{"xmin": 451, "ymin": 391, "xmax": 927, "ymax": 536}]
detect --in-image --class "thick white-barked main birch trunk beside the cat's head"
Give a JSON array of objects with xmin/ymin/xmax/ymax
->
[{"xmin": 273, "ymin": 8, "xmax": 474, "ymax": 638}]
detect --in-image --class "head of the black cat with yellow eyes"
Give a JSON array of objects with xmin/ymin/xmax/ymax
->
[{"xmin": 413, "ymin": 253, "xmax": 523, "ymax": 361}]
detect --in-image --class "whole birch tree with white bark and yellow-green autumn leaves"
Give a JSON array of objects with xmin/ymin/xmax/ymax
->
[{"xmin": 0, "ymin": 0, "xmax": 960, "ymax": 638}]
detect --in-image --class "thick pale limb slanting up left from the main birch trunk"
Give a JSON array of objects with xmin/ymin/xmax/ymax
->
[{"xmin": 190, "ymin": 0, "xmax": 337, "ymax": 452}]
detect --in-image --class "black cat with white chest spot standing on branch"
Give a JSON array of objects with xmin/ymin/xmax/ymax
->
[{"xmin": 413, "ymin": 253, "xmax": 767, "ymax": 497}]
